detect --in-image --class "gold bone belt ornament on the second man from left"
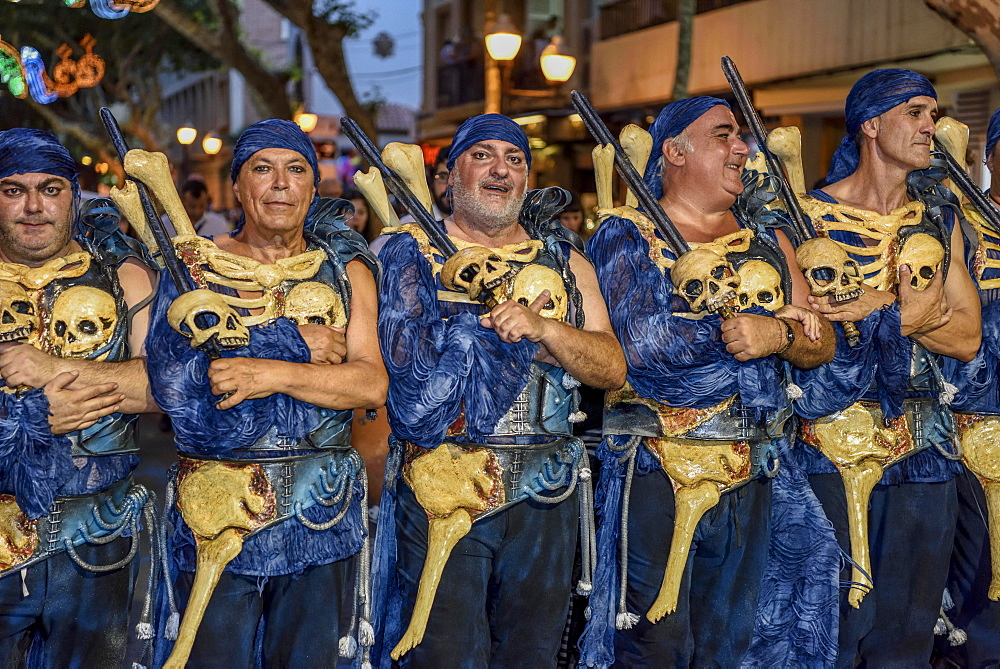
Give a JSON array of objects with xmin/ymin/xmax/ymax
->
[{"xmin": 163, "ymin": 457, "xmax": 278, "ymax": 669}]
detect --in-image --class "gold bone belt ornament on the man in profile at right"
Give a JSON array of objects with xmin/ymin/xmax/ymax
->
[{"xmin": 802, "ymin": 400, "xmax": 937, "ymax": 608}]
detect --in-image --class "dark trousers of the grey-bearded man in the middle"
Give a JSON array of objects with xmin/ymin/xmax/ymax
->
[{"xmin": 396, "ymin": 483, "xmax": 579, "ymax": 669}]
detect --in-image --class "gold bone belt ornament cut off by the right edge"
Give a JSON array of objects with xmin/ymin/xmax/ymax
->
[{"xmin": 955, "ymin": 413, "xmax": 1000, "ymax": 600}]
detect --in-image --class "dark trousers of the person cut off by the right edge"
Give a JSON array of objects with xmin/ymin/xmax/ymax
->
[{"xmin": 938, "ymin": 471, "xmax": 1000, "ymax": 669}]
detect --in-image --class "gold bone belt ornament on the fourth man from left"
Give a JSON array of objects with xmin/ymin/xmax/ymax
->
[{"xmin": 646, "ymin": 436, "xmax": 751, "ymax": 623}]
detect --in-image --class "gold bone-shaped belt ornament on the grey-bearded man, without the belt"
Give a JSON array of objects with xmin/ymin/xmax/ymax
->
[{"xmin": 391, "ymin": 442, "xmax": 504, "ymax": 660}]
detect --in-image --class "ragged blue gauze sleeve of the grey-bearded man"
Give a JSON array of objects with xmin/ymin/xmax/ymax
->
[{"xmin": 378, "ymin": 234, "xmax": 537, "ymax": 448}]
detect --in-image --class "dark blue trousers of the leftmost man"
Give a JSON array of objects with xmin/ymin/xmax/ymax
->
[{"xmin": 0, "ymin": 537, "xmax": 139, "ymax": 669}]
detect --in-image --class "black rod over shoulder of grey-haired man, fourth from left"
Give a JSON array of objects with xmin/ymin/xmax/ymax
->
[{"xmin": 570, "ymin": 91, "xmax": 735, "ymax": 319}]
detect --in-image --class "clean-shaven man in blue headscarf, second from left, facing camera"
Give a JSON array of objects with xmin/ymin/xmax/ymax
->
[{"xmin": 147, "ymin": 119, "xmax": 387, "ymax": 667}]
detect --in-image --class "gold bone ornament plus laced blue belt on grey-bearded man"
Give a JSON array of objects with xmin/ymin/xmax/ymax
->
[{"xmin": 392, "ymin": 439, "xmax": 582, "ymax": 660}]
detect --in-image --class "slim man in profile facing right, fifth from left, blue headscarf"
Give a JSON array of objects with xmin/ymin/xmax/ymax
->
[{"xmin": 794, "ymin": 69, "xmax": 980, "ymax": 667}]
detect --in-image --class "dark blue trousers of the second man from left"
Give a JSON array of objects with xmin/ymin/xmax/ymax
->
[{"xmin": 177, "ymin": 558, "xmax": 353, "ymax": 669}]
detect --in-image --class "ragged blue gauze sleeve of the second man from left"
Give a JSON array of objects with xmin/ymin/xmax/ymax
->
[{"xmin": 146, "ymin": 273, "xmax": 319, "ymax": 455}]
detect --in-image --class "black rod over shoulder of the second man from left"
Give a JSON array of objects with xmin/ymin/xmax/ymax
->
[{"xmin": 101, "ymin": 107, "xmax": 224, "ymax": 362}]
